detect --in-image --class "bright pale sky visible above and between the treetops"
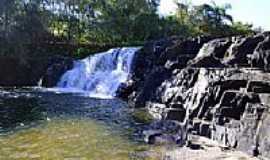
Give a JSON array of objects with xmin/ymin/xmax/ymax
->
[{"xmin": 160, "ymin": 0, "xmax": 270, "ymax": 31}]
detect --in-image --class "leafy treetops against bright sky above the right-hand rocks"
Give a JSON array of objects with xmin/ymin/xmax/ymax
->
[{"xmin": 171, "ymin": 2, "xmax": 252, "ymax": 36}]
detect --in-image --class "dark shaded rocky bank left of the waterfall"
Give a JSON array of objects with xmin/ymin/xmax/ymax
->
[{"xmin": 0, "ymin": 56, "xmax": 73, "ymax": 87}]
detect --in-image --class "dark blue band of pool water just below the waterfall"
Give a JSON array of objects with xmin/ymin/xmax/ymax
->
[{"xmin": 0, "ymin": 89, "xmax": 136, "ymax": 132}]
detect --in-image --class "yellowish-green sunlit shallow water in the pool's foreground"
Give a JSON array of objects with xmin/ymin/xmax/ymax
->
[{"xmin": 0, "ymin": 118, "xmax": 160, "ymax": 160}]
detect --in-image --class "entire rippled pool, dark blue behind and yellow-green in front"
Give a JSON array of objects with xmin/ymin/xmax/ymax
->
[{"xmin": 0, "ymin": 91, "xmax": 161, "ymax": 160}]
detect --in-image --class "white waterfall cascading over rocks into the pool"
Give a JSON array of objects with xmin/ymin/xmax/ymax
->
[{"xmin": 57, "ymin": 47, "xmax": 139, "ymax": 98}]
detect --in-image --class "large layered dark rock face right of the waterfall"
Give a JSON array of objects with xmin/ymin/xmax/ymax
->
[{"xmin": 118, "ymin": 33, "xmax": 270, "ymax": 158}]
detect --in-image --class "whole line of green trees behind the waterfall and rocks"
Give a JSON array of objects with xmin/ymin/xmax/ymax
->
[{"xmin": 0, "ymin": 0, "xmax": 254, "ymax": 57}]
